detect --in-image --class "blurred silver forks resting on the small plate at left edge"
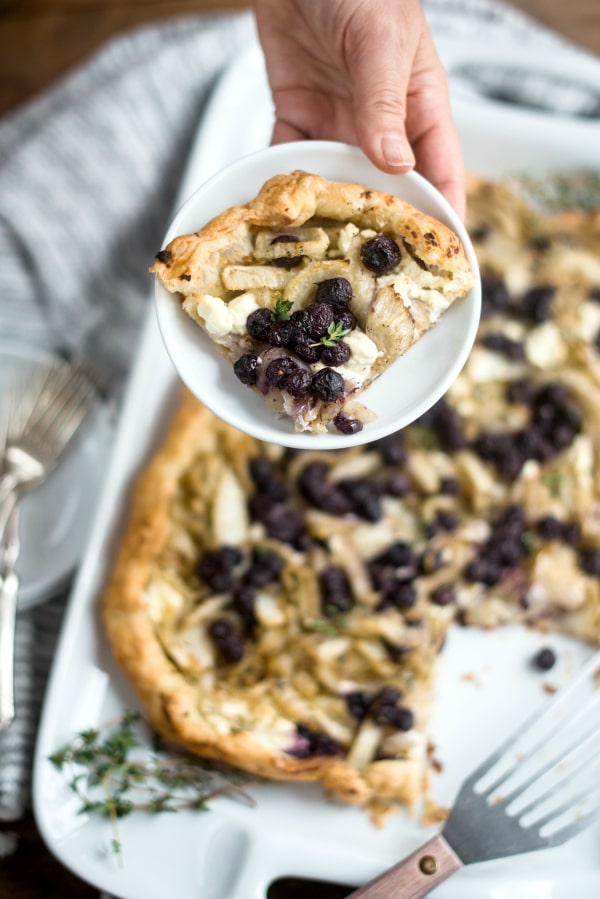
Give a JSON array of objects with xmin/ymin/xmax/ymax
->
[{"xmin": 0, "ymin": 359, "xmax": 95, "ymax": 731}]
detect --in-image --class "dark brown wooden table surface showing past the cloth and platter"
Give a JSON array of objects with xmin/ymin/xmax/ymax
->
[{"xmin": 0, "ymin": 0, "xmax": 600, "ymax": 899}]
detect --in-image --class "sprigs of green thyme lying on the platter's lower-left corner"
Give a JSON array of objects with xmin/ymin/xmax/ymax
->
[{"xmin": 49, "ymin": 711, "xmax": 252, "ymax": 861}]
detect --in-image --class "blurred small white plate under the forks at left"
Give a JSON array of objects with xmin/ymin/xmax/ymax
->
[{"xmin": 0, "ymin": 343, "xmax": 109, "ymax": 610}]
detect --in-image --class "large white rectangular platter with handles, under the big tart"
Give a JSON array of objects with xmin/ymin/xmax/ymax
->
[{"xmin": 33, "ymin": 38, "xmax": 600, "ymax": 899}]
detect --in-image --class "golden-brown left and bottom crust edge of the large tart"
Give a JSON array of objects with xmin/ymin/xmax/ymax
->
[{"xmin": 101, "ymin": 391, "xmax": 426, "ymax": 806}]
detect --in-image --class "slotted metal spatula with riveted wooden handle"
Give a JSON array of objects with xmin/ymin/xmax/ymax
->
[{"xmin": 348, "ymin": 652, "xmax": 600, "ymax": 899}]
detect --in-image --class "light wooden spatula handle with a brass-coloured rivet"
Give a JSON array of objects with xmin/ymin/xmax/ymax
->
[{"xmin": 348, "ymin": 834, "xmax": 463, "ymax": 899}]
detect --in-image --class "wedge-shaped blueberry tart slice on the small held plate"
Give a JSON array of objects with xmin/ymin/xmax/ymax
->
[{"xmin": 151, "ymin": 171, "xmax": 473, "ymax": 433}]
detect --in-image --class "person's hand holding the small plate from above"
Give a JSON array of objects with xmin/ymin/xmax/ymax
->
[{"xmin": 254, "ymin": 0, "xmax": 465, "ymax": 217}]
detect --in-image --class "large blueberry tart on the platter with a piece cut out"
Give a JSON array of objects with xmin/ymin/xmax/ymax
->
[{"xmin": 108, "ymin": 179, "xmax": 600, "ymax": 805}]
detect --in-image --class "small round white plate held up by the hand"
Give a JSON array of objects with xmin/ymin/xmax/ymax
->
[{"xmin": 155, "ymin": 141, "xmax": 481, "ymax": 449}]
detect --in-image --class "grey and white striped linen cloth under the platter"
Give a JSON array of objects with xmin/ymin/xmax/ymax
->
[{"xmin": 0, "ymin": 0, "xmax": 592, "ymax": 821}]
